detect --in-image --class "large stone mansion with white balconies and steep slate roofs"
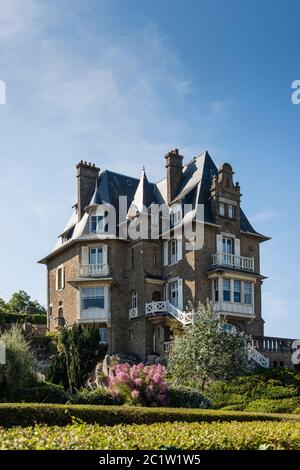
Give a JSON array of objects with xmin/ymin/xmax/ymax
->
[{"xmin": 40, "ymin": 149, "xmax": 291, "ymax": 367}]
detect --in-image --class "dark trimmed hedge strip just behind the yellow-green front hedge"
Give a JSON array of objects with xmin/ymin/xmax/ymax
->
[{"xmin": 0, "ymin": 403, "xmax": 300, "ymax": 428}]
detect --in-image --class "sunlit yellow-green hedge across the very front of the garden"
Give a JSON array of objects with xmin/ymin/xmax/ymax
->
[{"xmin": 0, "ymin": 421, "xmax": 300, "ymax": 450}]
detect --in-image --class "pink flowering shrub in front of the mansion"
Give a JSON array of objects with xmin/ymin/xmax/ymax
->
[{"xmin": 108, "ymin": 363, "xmax": 168, "ymax": 406}]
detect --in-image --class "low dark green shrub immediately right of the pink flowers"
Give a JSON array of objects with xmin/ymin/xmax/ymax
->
[{"xmin": 168, "ymin": 385, "xmax": 210, "ymax": 408}]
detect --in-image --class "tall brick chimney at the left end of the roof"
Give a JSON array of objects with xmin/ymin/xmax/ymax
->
[{"xmin": 76, "ymin": 160, "xmax": 100, "ymax": 219}]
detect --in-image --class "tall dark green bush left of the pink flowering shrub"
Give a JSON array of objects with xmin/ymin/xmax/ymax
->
[{"xmin": 47, "ymin": 323, "xmax": 107, "ymax": 392}]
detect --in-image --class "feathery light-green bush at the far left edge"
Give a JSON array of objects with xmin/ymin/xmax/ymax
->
[{"xmin": 0, "ymin": 326, "xmax": 36, "ymax": 401}]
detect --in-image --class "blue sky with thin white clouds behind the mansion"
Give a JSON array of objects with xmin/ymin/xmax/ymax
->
[{"xmin": 0, "ymin": 0, "xmax": 300, "ymax": 337}]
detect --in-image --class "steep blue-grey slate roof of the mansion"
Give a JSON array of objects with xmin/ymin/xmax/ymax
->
[{"xmin": 38, "ymin": 151, "xmax": 268, "ymax": 262}]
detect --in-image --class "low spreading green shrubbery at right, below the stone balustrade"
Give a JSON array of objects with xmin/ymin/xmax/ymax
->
[{"xmin": 207, "ymin": 368, "xmax": 300, "ymax": 409}]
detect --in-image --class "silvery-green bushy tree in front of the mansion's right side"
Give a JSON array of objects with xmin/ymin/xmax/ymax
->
[{"xmin": 168, "ymin": 303, "xmax": 247, "ymax": 390}]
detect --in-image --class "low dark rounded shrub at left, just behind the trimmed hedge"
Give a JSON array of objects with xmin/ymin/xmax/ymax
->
[{"xmin": 20, "ymin": 382, "xmax": 70, "ymax": 403}]
